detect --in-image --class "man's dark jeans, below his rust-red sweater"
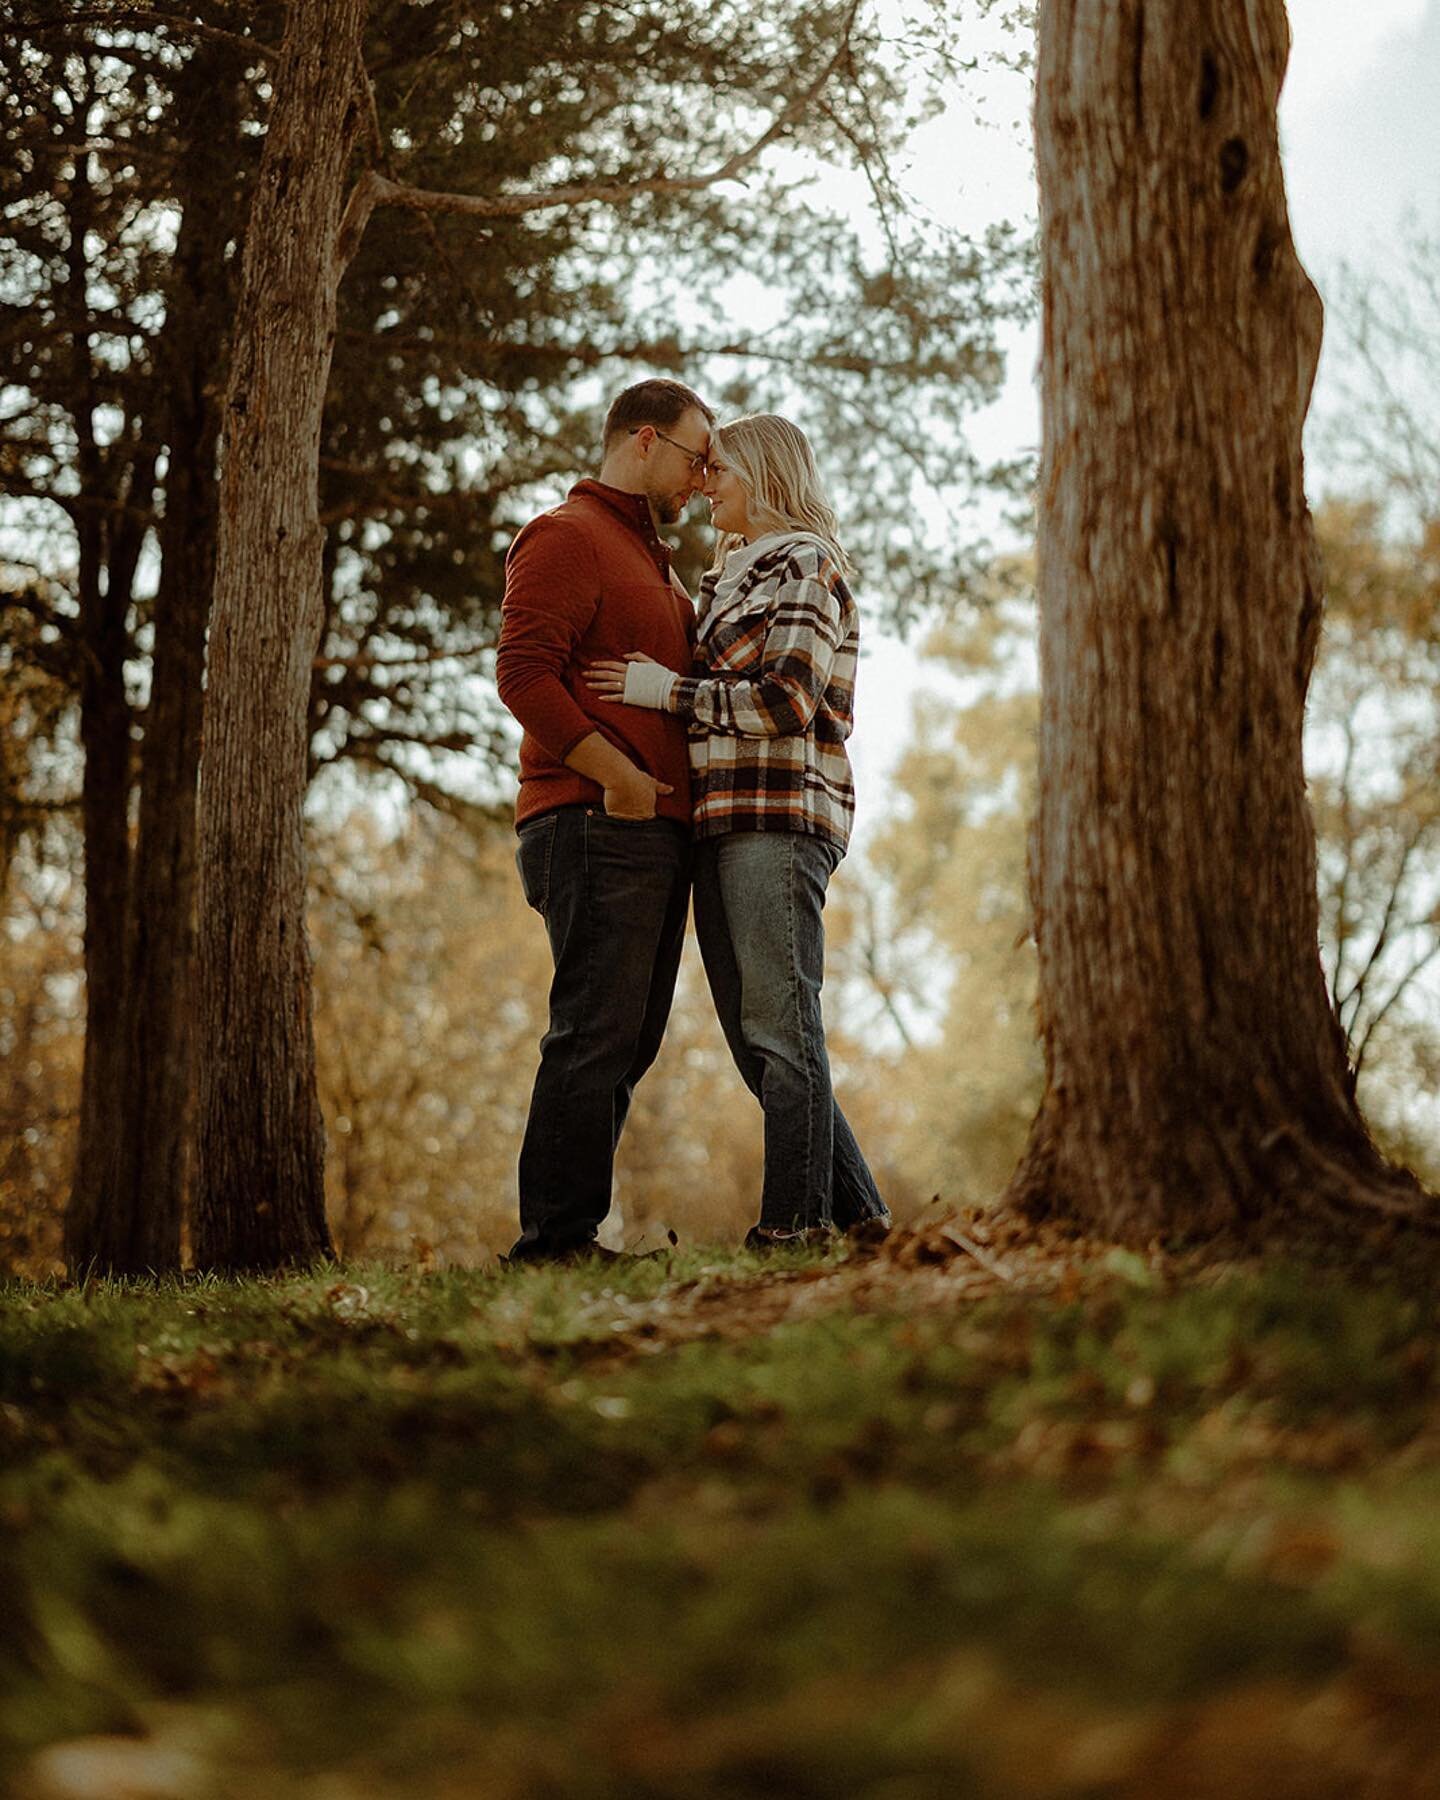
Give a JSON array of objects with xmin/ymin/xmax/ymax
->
[{"xmin": 511, "ymin": 806, "xmax": 691, "ymax": 1260}]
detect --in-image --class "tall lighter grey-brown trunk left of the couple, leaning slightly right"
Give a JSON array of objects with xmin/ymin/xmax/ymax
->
[{"xmin": 194, "ymin": 0, "xmax": 365, "ymax": 1269}]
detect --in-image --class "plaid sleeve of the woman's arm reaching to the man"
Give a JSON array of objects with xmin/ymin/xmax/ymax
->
[{"xmin": 670, "ymin": 562, "xmax": 844, "ymax": 738}]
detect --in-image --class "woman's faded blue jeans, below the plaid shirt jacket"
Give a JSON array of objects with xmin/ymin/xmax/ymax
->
[{"xmin": 695, "ymin": 832, "xmax": 889, "ymax": 1229}]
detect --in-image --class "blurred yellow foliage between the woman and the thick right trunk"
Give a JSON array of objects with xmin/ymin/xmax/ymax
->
[{"xmin": 839, "ymin": 576, "xmax": 1040, "ymax": 1204}]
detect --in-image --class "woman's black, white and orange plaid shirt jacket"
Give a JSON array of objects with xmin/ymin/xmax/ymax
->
[{"xmin": 670, "ymin": 531, "xmax": 860, "ymax": 851}]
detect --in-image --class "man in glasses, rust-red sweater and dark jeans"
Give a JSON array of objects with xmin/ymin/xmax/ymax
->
[{"xmin": 495, "ymin": 380, "xmax": 715, "ymax": 1262}]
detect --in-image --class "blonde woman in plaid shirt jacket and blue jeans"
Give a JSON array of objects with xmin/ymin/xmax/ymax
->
[{"xmin": 585, "ymin": 412, "xmax": 889, "ymax": 1249}]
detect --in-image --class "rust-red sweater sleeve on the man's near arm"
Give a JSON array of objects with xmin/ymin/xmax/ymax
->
[{"xmin": 495, "ymin": 515, "xmax": 599, "ymax": 763}]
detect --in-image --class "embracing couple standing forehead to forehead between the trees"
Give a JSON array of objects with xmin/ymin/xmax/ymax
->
[{"xmin": 497, "ymin": 380, "xmax": 889, "ymax": 1264}]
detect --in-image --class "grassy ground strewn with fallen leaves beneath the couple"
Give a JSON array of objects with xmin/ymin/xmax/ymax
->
[{"xmin": 0, "ymin": 1215, "xmax": 1440, "ymax": 1800}]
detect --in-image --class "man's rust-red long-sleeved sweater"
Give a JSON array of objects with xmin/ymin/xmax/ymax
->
[{"xmin": 495, "ymin": 481, "xmax": 695, "ymax": 824}]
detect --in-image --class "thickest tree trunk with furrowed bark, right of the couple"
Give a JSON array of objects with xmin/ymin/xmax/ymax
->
[{"xmin": 1012, "ymin": 0, "xmax": 1424, "ymax": 1238}]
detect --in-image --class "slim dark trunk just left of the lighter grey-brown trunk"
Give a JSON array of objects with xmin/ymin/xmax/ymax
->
[{"xmin": 97, "ymin": 47, "xmax": 238, "ymax": 1273}]
